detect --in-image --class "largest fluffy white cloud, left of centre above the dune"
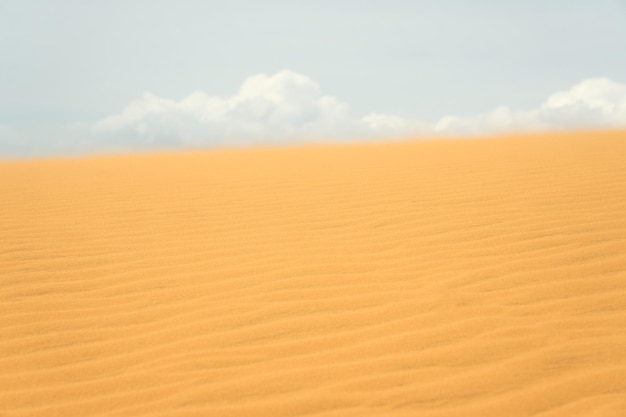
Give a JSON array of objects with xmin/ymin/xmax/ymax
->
[{"xmin": 94, "ymin": 71, "xmax": 362, "ymax": 150}]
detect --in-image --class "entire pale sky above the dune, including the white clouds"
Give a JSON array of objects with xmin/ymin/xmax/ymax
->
[{"xmin": 0, "ymin": 0, "xmax": 626, "ymax": 158}]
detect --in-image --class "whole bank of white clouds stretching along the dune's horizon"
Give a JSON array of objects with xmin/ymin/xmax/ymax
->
[{"xmin": 0, "ymin": 70, "xmax": 626, "ymax": 154}]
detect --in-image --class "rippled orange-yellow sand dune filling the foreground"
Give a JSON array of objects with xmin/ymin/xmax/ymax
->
[{"xmin": 0, "ymin": 132, "xmax": 626, "ymax": 417}]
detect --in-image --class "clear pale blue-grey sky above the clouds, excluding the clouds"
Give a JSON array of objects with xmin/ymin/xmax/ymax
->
[{"xmin": 0, "ymin": 0, "xmax": 626, "ymax": 157}]
